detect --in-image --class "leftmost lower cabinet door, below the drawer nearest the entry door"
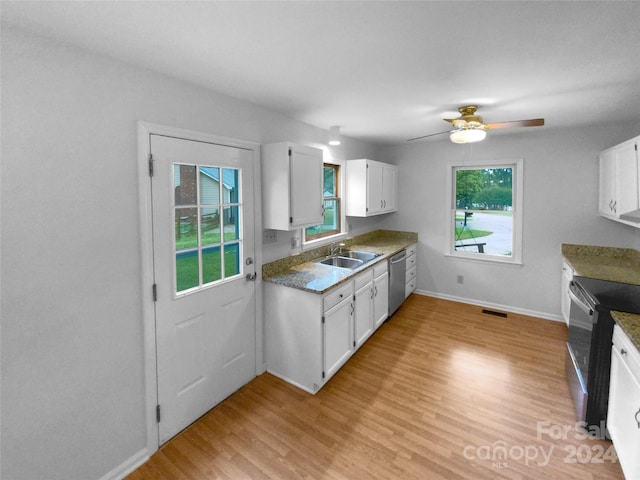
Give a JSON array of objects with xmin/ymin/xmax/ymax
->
[{"xmin": 322, "ymin": 296, "xmax": 354, "ymax": 380}]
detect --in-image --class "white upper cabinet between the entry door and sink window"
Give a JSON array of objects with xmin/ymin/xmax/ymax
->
[{"xmin": 262, "ymin": 142, "xmax": 324, "ymax": 230}]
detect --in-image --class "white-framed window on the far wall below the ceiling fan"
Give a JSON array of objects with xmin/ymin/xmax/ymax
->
[{"xmin": 447, "ymin": 159, "xmax": 523, "ymax": 264}]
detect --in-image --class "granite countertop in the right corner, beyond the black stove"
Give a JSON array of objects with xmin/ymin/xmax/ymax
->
[{"xmin": 562, "ymin": 244, "xmax": 640, "ymax": 285}]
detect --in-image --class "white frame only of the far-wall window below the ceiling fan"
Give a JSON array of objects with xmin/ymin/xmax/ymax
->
[{"xmin": 445, "ymin": 158, "xmax": 524, "ymax": 265}]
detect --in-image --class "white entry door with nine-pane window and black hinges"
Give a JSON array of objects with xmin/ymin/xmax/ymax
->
[{"xmin": 150, "ymin": 134, "xmax": 256, "ymax": 443}]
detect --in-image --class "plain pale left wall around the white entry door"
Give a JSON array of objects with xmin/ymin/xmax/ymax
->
[{"xmin": 0, "ymin": 28, "xmax": 375, "ymax": 480}]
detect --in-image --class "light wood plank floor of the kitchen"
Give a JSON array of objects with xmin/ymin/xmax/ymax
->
[{"xmin": 128, "ymin": 295, "xmax": 623, "ymax": 480}]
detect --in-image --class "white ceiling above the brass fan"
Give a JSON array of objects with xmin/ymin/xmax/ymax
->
[{"xmin": 1, "ymin": 0, "xmax": 640, "ymax": 144}]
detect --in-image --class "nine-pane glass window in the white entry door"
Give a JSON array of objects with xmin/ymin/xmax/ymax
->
[{"xmin": 173, "ymin": 164, "xmax": 242, "ymax": 293}]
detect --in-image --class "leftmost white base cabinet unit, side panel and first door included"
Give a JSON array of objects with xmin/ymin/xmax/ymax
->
[{"xmin": 264, "ymin": 281, "xmax": 355, "ymax": 393}]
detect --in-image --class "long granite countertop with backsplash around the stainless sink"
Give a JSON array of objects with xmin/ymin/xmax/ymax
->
[{"xmin": 262, "ymin": 230, "xmax": 418, "ymax": 294}]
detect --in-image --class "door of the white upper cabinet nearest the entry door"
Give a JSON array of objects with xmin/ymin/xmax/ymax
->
[{"xmin": 290, "ymin": 145, "xmax": 324, "ymax": 227}]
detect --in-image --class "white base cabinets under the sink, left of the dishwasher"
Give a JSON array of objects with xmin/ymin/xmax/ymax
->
[{"xmin": 263, "ymin": 261, "xmax": 389, "ymax": 393}]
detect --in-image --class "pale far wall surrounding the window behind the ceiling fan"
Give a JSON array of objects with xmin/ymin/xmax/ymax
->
[{"xmin": 381, "ymin": 124, "xmax": 640, "ymax": 319}]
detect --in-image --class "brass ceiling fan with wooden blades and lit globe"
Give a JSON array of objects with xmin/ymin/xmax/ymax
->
[{"xmin": 407, "ymin": 105, "xmax": 544, "ymax": 143}]
